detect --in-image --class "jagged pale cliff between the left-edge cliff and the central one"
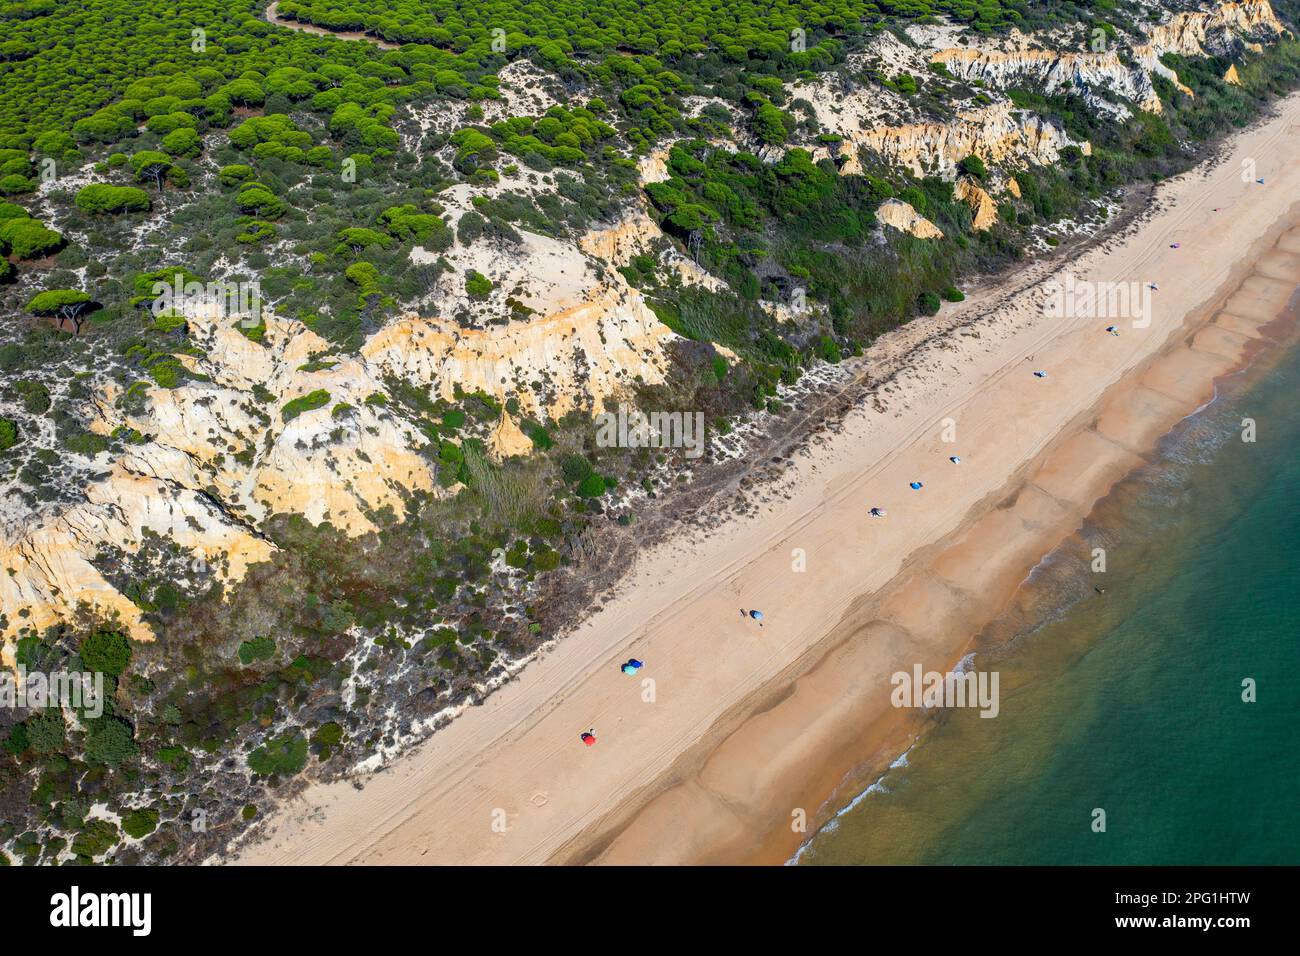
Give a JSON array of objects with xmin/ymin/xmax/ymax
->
[{"xmin": 107, "ymin": 304, "xmax": 434, "ymax": 535}]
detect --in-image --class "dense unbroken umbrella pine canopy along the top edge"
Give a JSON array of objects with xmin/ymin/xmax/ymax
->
[{"xmin": 0, "ymin": 0, "xmax": 1086, "ymax": 142}]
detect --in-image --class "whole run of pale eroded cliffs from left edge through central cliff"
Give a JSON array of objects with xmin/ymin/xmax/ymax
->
[{"xmin": 0, "ymin": 222, "xmax": 675, "ymax": 650}]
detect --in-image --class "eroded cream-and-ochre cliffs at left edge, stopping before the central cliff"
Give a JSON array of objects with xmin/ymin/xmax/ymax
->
[{"xmin": 0, "ymin": 303, "xmax": 436, "ymax": 659}]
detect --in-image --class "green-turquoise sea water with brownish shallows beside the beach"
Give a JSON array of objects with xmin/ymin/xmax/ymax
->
[{"xmin": 798, "ymin": 319, "xmax": 1300, "ymax": 865}]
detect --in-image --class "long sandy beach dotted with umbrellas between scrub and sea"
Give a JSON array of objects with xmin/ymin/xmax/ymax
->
[{"xmin": 238, "ymin": 95, "xmax": 1300, "ymax": 865}]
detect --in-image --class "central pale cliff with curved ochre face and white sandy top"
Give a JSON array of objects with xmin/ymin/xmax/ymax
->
[{"xmin": 377, "ymin": 209, "xmax": 681, "ymax": 419}]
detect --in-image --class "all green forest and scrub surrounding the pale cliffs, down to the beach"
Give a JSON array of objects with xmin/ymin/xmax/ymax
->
[{"xmin": 0, "ymin": 0, "xmax": 1300, "ymax": 862}]
